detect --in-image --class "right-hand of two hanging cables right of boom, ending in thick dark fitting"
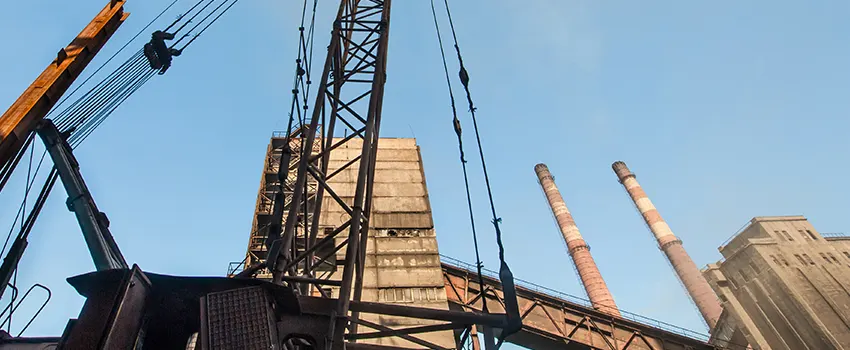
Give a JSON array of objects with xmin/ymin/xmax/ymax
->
[{"xmin": 432, "ymin": 0, "xmax": 522, "ymax": 347}]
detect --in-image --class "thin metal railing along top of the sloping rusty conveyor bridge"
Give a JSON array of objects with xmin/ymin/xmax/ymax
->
[{"xmin": 440, "ymin": 254, "xmax": 709, "ymax": 342}]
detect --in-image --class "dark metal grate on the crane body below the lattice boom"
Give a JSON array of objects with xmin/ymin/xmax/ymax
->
[{"xmin": 206, "ymin": 287, "xmax": 276, "ymax": 350}]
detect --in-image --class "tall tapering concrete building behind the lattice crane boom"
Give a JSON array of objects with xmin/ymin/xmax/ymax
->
[{"xmin": 246, "ymin": 134, "xmax": 455, "ymax": 348}]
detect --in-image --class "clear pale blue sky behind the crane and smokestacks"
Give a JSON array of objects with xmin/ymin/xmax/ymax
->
[{"xmin": 0, "ymin": 0, "xmax": 850, "ymax": 346}]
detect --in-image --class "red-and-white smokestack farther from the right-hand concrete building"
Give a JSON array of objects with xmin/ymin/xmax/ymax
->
[{"xmin": 534, "ymin": 164, "xmax": 620, "ymax": 316}]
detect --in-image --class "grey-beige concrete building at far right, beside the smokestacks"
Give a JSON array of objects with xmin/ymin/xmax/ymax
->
[{"xmin": 703, "ymin": 216, "xmax": 850, "ymax": 350}]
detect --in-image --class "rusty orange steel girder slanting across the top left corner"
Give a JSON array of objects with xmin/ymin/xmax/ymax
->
[{"xmin": 0, "ymin": 0, "xmax": 130, "ymax": 171}]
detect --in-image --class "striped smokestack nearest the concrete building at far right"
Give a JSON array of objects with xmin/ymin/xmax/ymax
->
[{"xmin": 611, "ymin": 162, "xmax": 723, "ymax": 329}]
